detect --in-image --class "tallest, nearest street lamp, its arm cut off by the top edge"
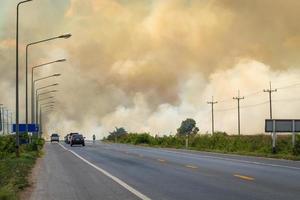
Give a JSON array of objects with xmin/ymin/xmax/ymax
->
[{"xmin": 16, "ymin": 0, "xmax": 32, "ymax": 157}]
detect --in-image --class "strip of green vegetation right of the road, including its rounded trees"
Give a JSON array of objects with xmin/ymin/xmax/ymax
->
[{"xmin": 104, "ymin": 119, "xmax": 300, "ymax": 160}]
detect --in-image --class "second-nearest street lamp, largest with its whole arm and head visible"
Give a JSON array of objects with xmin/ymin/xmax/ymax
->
[{"xmin": 25, "ymin": 34, "xmax": 72, "ymax": 131}]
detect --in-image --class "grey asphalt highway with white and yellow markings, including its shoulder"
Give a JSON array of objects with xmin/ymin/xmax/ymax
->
[{"xmin": 31, "ymin": 143, "xmax": 300, "ymax": 200}]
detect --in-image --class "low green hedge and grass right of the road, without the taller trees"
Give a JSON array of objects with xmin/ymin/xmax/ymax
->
[{"xmin": 105, "ymin": 132, "xmax": 300, "ymax": 158}]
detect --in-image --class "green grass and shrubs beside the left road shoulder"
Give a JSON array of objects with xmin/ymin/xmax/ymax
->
[{"xmin": 0, "ymin": 135, "xmax": 44, "ymax": 200}]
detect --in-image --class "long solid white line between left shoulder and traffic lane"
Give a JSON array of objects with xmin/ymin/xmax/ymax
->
[{"xmin": 59, "ymin": 144, "xmax": 151, "ymax": 200}]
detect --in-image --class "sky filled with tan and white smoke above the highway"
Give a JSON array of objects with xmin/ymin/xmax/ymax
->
[{"xmin": 0, "ymin": 0, "xmax": 300, "ymax": 138}]
